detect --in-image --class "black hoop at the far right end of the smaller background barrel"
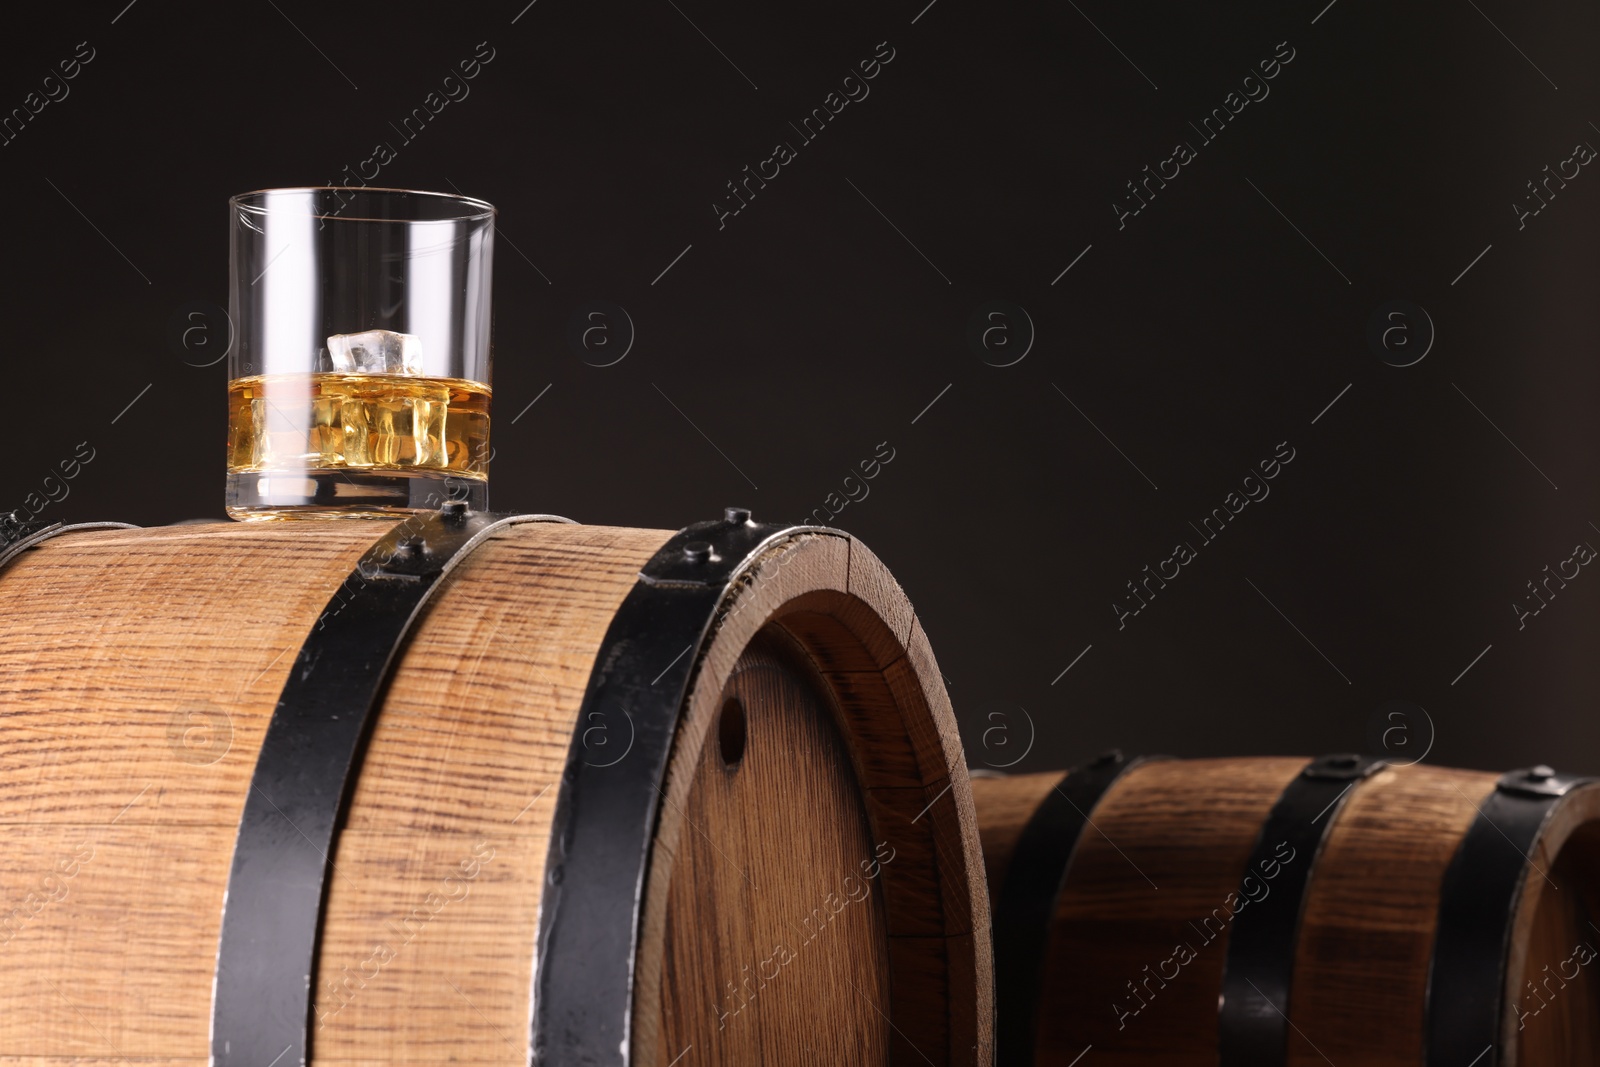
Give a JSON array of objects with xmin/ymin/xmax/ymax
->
[{"xmin": 1427, "ymin": 766, "xmax": 1600, "ymax": 1067}]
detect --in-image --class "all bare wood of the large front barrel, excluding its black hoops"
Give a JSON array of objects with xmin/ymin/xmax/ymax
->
[{"xmin": 0, "ymin": 522, "xmax": 989, "ymax": 1067}]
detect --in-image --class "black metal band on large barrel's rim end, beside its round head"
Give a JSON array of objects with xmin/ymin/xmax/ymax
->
[{"xmin": 533, "ymin": 507, "xmax": 814, "ymax": 1067}]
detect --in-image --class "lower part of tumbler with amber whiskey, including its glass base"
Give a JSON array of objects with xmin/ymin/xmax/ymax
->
[{"xmin": 227, "ymin": 373, "xmax": 490, "ymax": 518}]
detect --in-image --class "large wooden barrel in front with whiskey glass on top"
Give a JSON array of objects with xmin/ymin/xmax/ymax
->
[{"xmin": 0, "ymin": 507, "xmax": 992, "ymax": 1067}]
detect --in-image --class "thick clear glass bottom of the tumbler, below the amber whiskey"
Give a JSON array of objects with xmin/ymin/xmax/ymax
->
[{"xmin": 227, "ymin": 469, "xmax": 490, "ymax": 522}]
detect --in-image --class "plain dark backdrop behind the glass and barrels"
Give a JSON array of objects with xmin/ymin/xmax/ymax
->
[{"xmin": 0, "ymin": 0, "xmax": 1600, "ymax": 771}]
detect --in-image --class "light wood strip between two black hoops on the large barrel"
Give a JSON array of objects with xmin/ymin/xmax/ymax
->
[{"xmin": 314, "ymin": 523, "xmax": 667, "ymax": 1064}]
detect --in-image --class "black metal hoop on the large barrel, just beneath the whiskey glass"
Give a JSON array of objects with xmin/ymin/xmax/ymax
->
[{"xmin": 211, "ymin": 501, "xmax": 571, "ymax": 1067}]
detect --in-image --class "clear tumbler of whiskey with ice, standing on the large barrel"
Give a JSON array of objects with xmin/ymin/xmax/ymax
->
[{"xmin": 227, "ymin": 187, "xmax": 494, "ymax": 520}]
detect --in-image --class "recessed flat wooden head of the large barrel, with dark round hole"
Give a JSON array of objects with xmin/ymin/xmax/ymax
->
[{"xmin": 662, "ymin": 637, "xmax": 890, "ymax": 1067}]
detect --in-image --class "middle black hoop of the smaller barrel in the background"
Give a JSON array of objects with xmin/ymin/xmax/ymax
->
[{"xmin": 1218, "ymin": 755, "xmax": 1388, "ymax": 1067}]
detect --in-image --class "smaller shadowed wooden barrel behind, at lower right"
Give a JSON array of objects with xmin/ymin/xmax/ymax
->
[{"xmin": 973, "ymin": 753, "xmax": 1600, "ymax": 1067}]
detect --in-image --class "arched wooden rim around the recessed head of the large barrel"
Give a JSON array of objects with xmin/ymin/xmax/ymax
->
[{"xmin": 635, "ymin": 534, "xmax": 994, "ymax": 1067}]
